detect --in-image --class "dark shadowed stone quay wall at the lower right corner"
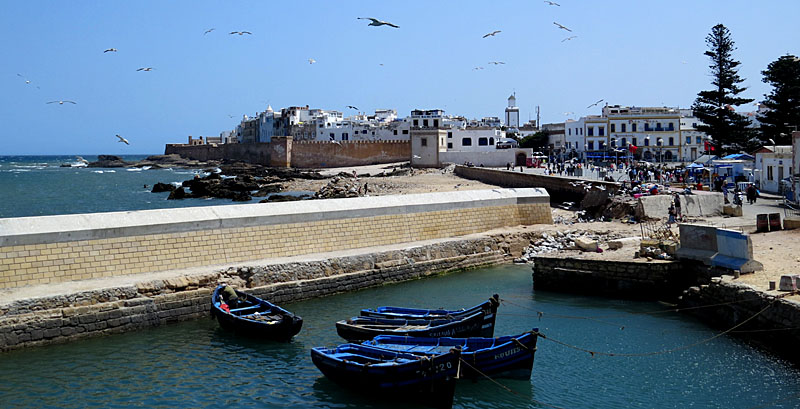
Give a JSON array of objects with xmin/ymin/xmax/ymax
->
[{"xmin": 679, "ymin": 276, "xmax": 800, "ymax": 363}]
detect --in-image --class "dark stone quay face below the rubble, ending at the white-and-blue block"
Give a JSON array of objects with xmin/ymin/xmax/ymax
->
[{"xmin": 533, "ymin": 256, "xmax": 697, "ymax": 300}]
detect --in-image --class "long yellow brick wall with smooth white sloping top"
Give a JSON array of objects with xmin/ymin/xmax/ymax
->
[{"xmin": 0, "ymin": 189, "xmax": 552, "ymax": 288}]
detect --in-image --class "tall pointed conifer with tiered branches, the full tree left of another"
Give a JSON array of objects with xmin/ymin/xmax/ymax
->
[{"xmin": 692, "ymin": 24, "xmax": 754, "ymax": 153}]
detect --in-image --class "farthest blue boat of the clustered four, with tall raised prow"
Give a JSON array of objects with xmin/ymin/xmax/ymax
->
[{"xmin": 361, "ymin": 294, "xmax": 500, "ymax": 337}]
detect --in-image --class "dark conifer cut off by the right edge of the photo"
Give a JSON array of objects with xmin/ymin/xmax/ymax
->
[{"xmin": 758, "ymin": 55, "xmax": 800, "ymax": 145}]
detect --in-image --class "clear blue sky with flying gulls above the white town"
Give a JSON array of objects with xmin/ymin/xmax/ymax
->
[{"xmin": 0, "ymin": 0, "xmax": 800, "ymax": 155}]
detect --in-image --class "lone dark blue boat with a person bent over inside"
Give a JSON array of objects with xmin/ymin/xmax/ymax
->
[{"xmin": 211, "ymin": 286, "xmax": 303, "ymax": 341}]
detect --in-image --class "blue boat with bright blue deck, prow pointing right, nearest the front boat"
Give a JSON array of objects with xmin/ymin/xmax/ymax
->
[{"xmin": 364, "ymin": 328, "xmax": 539, "ymax": 379}]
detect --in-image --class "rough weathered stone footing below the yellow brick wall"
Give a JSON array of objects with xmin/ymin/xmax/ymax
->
[{"xmin": 0, "ymin": 235, "xmax": 529, "ymax": 351}]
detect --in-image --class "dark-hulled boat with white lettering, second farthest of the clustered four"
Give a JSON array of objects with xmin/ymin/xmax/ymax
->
[{"xmin": 336, "ymin": 312, "xmax": 494, "ymax": 342}]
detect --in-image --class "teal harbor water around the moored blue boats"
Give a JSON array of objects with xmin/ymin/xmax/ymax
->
[{"xmin": 0, "ymin": 265, "xmax": 800, "ymax": 408}]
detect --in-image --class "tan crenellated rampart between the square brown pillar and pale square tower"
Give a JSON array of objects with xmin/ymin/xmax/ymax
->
[{"xmin": 291, "ymin": 141, "xmax": 411, "ymax": 168}]
